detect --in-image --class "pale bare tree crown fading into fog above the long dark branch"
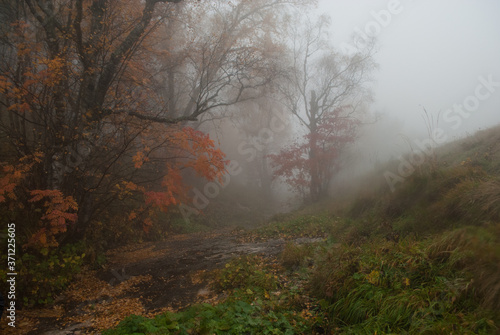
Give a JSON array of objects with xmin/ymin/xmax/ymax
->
[{"xmin": 146, "ymin": 0, "xmax": 311, "ymax": 121}]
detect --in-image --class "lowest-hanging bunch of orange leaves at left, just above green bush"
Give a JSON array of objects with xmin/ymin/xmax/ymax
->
[{"xmin": 27, "ymin": 190, "xmax": 78, "ymax": 248}]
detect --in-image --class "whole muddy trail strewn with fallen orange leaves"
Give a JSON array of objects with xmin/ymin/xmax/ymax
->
[{"xmin": 16, "ymin": 230, "xmax": 320, "ymax": 335}]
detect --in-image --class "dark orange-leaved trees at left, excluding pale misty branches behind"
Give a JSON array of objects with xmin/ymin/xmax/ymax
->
[{"xmin": 0, "ymin": 0, "xmax": 230, "ymax": 250}]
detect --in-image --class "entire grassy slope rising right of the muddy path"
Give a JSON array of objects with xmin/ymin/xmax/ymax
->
[{"xmin": 107, "ymin": 127, "xmax": 500, "ymax": 334}]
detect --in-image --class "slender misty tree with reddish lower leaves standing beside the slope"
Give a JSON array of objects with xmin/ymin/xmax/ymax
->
[{"xmin": 270, "ymin": 16, "xmax": 375, "ymax": 202}]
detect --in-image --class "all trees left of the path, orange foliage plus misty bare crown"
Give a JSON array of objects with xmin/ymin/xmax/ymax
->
[{"xmin": 0, "ymin": 0, "xmax": 320, "ymax": 308}]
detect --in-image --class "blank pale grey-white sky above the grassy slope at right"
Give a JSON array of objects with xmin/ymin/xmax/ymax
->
[{"xmin": 319, "ymin": 0, "xmax": 500, "ymax": 150}]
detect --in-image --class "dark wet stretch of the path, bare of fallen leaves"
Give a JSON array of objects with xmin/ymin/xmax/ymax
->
[{"xmin": 101, "ymin": 231, "xmax": 284, "ymax": 311}]
